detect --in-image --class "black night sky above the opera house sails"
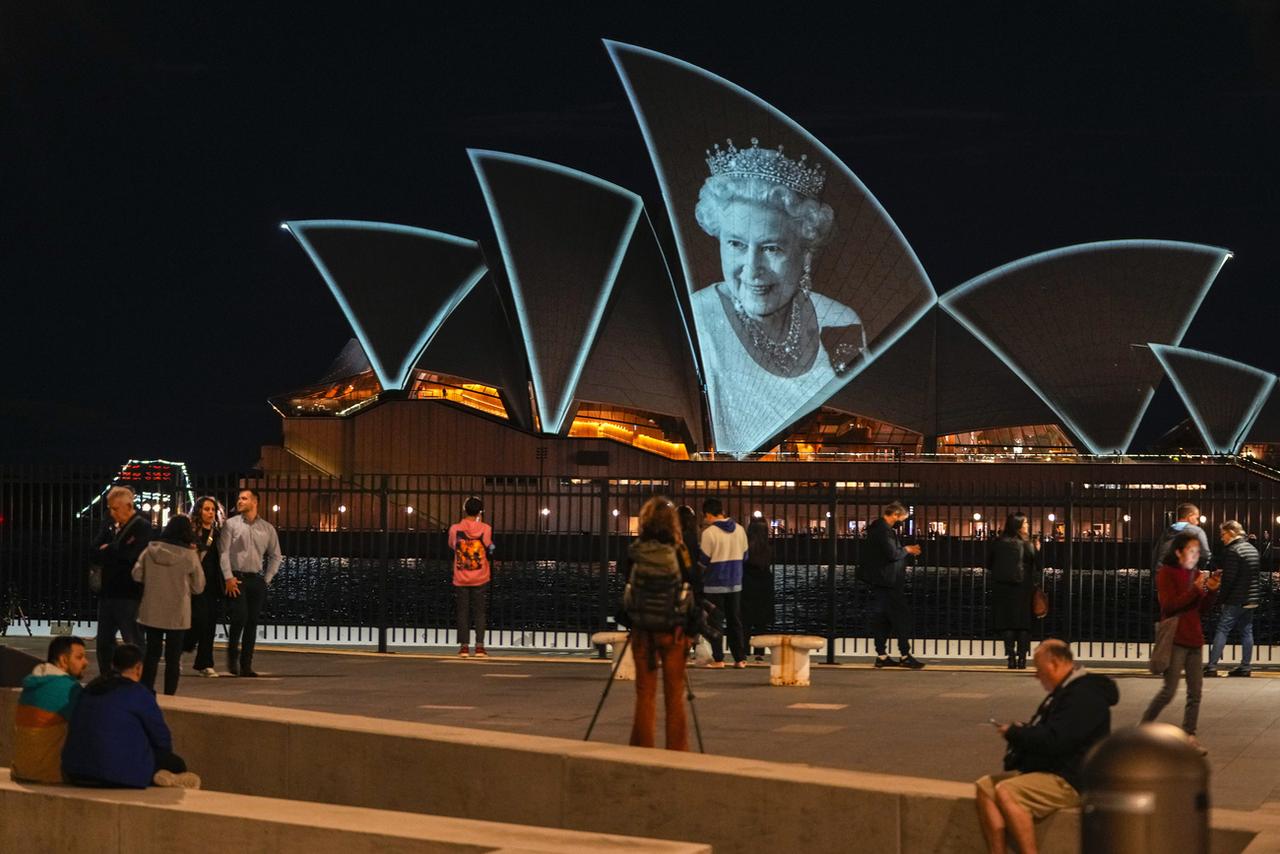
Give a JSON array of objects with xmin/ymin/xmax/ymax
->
[{"xmin": 0, "ymin": 0, "xmax": 1280, "ymax": 471}]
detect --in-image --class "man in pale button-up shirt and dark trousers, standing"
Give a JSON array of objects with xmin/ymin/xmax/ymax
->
[{"xmin": 218, "ymin": 489, "xmax": 284, "ymax": 676}]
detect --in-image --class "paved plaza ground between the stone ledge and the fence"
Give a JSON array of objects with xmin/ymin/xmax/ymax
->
[{"xmin": 6, "ymin": 636, "xmax": 1280, "ymax": 809}]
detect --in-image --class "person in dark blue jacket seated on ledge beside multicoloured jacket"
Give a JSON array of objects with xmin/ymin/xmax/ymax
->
[{"xmin": 63, "ymin": 644, "xmax": 200, "ymax": 789}]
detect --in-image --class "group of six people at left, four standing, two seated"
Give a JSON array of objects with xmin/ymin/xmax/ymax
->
[{"xmin": 12, "ymin": 487, "xmax": 283, "ymax": 789}]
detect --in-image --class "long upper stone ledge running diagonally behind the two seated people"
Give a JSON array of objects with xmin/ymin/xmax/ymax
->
[{"xmin": 0, "ymin": 690, "xmax": 1259, "ymax": 854}]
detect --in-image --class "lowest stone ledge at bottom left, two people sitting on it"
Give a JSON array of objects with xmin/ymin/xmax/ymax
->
[{"xmin": 0, "ymin": 768, "xmax": 712, "ymax": 854}]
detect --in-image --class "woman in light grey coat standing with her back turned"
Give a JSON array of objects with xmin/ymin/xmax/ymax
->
[{"xmin": 133, "ymin": 515, "xmax": 205, "ymax": 694}]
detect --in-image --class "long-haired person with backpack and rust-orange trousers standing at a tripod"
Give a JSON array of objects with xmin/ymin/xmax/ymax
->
[{"xmin": 622, "ymin": 495, "xmax": 699, "ymax": 750}]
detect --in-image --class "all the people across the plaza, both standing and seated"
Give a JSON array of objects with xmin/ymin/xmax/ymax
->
[{"xmin": 5, "ymin": 488, "xmax": 1261, "ymax": 851}]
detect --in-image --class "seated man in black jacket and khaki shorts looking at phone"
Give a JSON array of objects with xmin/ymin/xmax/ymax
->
[{"xmin": 975, "ymin": 640, "xmax": 1120, "ymax": 854}]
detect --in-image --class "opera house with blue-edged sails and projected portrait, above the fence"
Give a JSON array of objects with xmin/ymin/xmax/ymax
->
[{"xmin": 261, "ymin": 42, "xmax": 1280, "ymax": 478}]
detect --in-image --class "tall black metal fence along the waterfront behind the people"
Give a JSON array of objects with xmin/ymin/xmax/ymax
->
[{"xmin": 0, "ymin": 463, "xmax": 1280, "ymax": 661}]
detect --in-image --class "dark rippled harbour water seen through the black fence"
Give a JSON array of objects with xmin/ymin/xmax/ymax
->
[{"xmin": 259, "ymin": 558, "xmax": 1277, "ymax": 643}]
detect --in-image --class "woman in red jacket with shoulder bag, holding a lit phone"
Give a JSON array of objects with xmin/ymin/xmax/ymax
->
[{"xmin": 1142, "ymin": 531, "xmax": 1222, "ymax": 748}]
